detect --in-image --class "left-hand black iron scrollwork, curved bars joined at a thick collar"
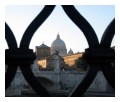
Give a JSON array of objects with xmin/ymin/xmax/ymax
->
[{"xmin": 5, "ymin": 6, "xmax": 55, "ymax": 97}]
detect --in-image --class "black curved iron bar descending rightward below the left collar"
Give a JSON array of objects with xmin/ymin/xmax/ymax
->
[{"xmin": 20, "ymin": 66, "xmax": 50, "ymax": 97}]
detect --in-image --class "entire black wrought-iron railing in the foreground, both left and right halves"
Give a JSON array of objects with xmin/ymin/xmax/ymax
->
[{"xmin": 5, "ymin": 5, "xmax": 115, "ymax": 97}]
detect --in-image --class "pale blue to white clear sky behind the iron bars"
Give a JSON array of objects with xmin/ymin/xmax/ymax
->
[{"xmin": 5, "ymin": 5, "xmax": 115, "ymax": 53}]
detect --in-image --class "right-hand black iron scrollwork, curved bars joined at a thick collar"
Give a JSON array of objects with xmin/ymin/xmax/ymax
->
[{"xmin": 62, "ymin": 6, "xmax": 115, "ymax": 96}]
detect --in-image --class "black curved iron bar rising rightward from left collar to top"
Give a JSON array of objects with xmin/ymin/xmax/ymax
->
[{"xmin": 20, "ymin": 5, "xmax": 55, "ymax": 49}]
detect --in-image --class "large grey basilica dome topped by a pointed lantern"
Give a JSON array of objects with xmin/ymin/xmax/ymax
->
[{"xmin": 50, "ymin": 34, "xmax": 67, "ymax": 56}]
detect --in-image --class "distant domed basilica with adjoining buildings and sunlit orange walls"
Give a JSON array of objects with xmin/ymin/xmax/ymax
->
[{"xmin": 36, "ymin": 34, "xmax": 82, "ymax": 69}]
